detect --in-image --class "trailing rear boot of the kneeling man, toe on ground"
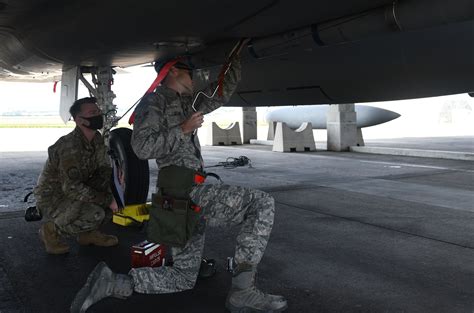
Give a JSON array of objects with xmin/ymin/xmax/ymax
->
[{"xmin": 71, "ymin": 262, "xmax": 133, "ymax": 313}]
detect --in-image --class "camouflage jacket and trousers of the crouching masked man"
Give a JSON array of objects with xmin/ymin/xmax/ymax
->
[{"xmin": 34, "ymin": 127, "xmax": 113, "ymax": 235}]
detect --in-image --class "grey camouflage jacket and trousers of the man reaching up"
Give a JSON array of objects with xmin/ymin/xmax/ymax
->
[{"xmin": 130, "ymin": 59, "xmax": 275, "ymax": 293}]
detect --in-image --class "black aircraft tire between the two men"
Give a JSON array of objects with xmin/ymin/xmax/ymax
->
[{"xmin": 109, "ymin": 127, "xmax": 150, "ymax": 205}]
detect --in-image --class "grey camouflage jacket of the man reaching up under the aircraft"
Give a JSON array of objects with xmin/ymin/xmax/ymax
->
[{"xmin": 132, "ymin": 58, "xmax": 240, "ymax": 170}]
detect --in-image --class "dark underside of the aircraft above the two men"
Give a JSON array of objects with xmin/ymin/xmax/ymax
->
[{"xmin": 0, "ymin": 0, "xmax": 474, "ymax": 106}]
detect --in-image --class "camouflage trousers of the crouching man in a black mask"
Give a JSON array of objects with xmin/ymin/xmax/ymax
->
[{"xmin": 36, "ymin": 198, "xmax": 106, "ymax": 236}]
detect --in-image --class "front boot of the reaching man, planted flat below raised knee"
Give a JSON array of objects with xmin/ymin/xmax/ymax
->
[{"xmin": 226, "ymin": 264, "xmax": 288, "ymax": 313}]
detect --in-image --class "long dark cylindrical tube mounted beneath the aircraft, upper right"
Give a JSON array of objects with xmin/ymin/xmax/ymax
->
[{"xmin": 249, "ymin": 0, "xmax": 474, "ymax": 59}]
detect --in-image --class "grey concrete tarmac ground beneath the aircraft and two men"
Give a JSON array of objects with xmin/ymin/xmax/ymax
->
[{"xmin": 0, "ymin": 146, "xmax": 474, "ymax": 313}]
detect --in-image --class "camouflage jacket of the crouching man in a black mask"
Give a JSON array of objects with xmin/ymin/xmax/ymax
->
[{"xmin": 35, "ymin": 127, "xmax": 113, "ymax": 207}]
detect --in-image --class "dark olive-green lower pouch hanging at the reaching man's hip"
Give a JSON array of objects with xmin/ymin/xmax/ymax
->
[{"xmin": 147, "ymin": 194, "xmax": 200, "ymax": 248}]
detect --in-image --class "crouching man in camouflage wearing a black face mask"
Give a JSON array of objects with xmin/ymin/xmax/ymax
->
[{"xmin": 34, "ymin": 98, "xmax": 118, "ymax": 254}]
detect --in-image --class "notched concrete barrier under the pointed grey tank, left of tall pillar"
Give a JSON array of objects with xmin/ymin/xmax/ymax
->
[{"xmin": 273, "ymin": 122, "xmax": 316, "ymax": 152}]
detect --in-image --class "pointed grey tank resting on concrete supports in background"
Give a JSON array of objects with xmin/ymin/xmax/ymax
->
[{"xmin": 265, "ymin": 105, "xmax": 400, "ymax": 129}]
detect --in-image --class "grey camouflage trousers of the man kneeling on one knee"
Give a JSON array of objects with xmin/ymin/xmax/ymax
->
[{"xmin": 129, "ymin": 185, "xmax": 275, "ymax": 293}]
